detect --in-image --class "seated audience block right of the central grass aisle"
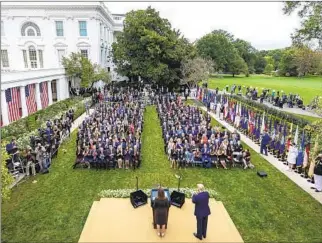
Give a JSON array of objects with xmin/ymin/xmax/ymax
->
[{"xmin": 157, "ymin": 95, "xmax": 254, "ymax": 169}]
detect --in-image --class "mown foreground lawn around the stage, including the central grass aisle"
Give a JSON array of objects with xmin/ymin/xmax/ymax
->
[{"xmin": 2, "ymin": 107, "xmax": 322, "ymax": 242}]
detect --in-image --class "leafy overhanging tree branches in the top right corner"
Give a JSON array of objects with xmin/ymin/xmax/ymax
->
[{"xmin": 283, "ymin": 1, "xmax": 322, "ymax": 48}]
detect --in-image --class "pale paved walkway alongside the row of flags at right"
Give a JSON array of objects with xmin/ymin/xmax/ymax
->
[{"xmin": 196, "ymin": 103, "xmax": 322, "ymax": 204}]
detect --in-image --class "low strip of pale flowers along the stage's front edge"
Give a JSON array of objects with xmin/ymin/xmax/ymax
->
[{"xmin": 98, "ymin": 187, "xmax": 218, "ymax": 198}]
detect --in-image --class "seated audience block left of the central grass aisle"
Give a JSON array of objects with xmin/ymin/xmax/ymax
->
[{"xmin": 73, "ymin": 88, "xmax": 144, "ymax": 169}]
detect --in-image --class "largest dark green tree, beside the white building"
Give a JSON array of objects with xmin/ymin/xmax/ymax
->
[{"xmin": 112, "ymin": 7, "xmax": 195, "ymax": 85}]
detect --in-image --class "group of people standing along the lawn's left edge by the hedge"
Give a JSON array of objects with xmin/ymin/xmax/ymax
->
[{"xmin": 6, "ymin": 109, "xmax": 74, "ymax": 176}]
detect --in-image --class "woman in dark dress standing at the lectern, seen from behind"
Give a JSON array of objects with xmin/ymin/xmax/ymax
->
[{"xmin": 153, "ymin": 188, "xmax": 170, "ymax": 237}]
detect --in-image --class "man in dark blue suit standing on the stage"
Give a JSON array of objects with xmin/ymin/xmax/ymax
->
[{"xmin": 192, "ymin": 184, "xmax": 210, "ymax": 240}]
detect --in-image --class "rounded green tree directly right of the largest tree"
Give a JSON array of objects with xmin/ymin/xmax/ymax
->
[{"xmin": 196, "ymin": 32, "xmax": 236, "ymax": 71}]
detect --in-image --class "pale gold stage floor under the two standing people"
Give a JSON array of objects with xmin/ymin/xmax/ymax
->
[{"xmin": 79, "ymin": 198, "xmax": 243, "ymax": 243}]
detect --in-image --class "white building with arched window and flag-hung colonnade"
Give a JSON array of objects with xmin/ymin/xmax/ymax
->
[{"xmin": 1, "ymin": 2, "xmax": 126, "ymax": 125}]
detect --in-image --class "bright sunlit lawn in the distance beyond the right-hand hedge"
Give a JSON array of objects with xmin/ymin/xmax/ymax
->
[{"xmin": 209, "ymin": 75, "xmax": 322, "ymax": 104}]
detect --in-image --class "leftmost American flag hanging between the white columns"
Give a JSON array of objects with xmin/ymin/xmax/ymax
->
[{"xmin": 5, "ymin": 87, "xmax": 21, "ymax": 122}]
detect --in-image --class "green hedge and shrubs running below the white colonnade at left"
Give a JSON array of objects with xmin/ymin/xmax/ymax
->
[{"xmin": 1, "ymin": 98, "xmax": 85, "ymax": 140}]
